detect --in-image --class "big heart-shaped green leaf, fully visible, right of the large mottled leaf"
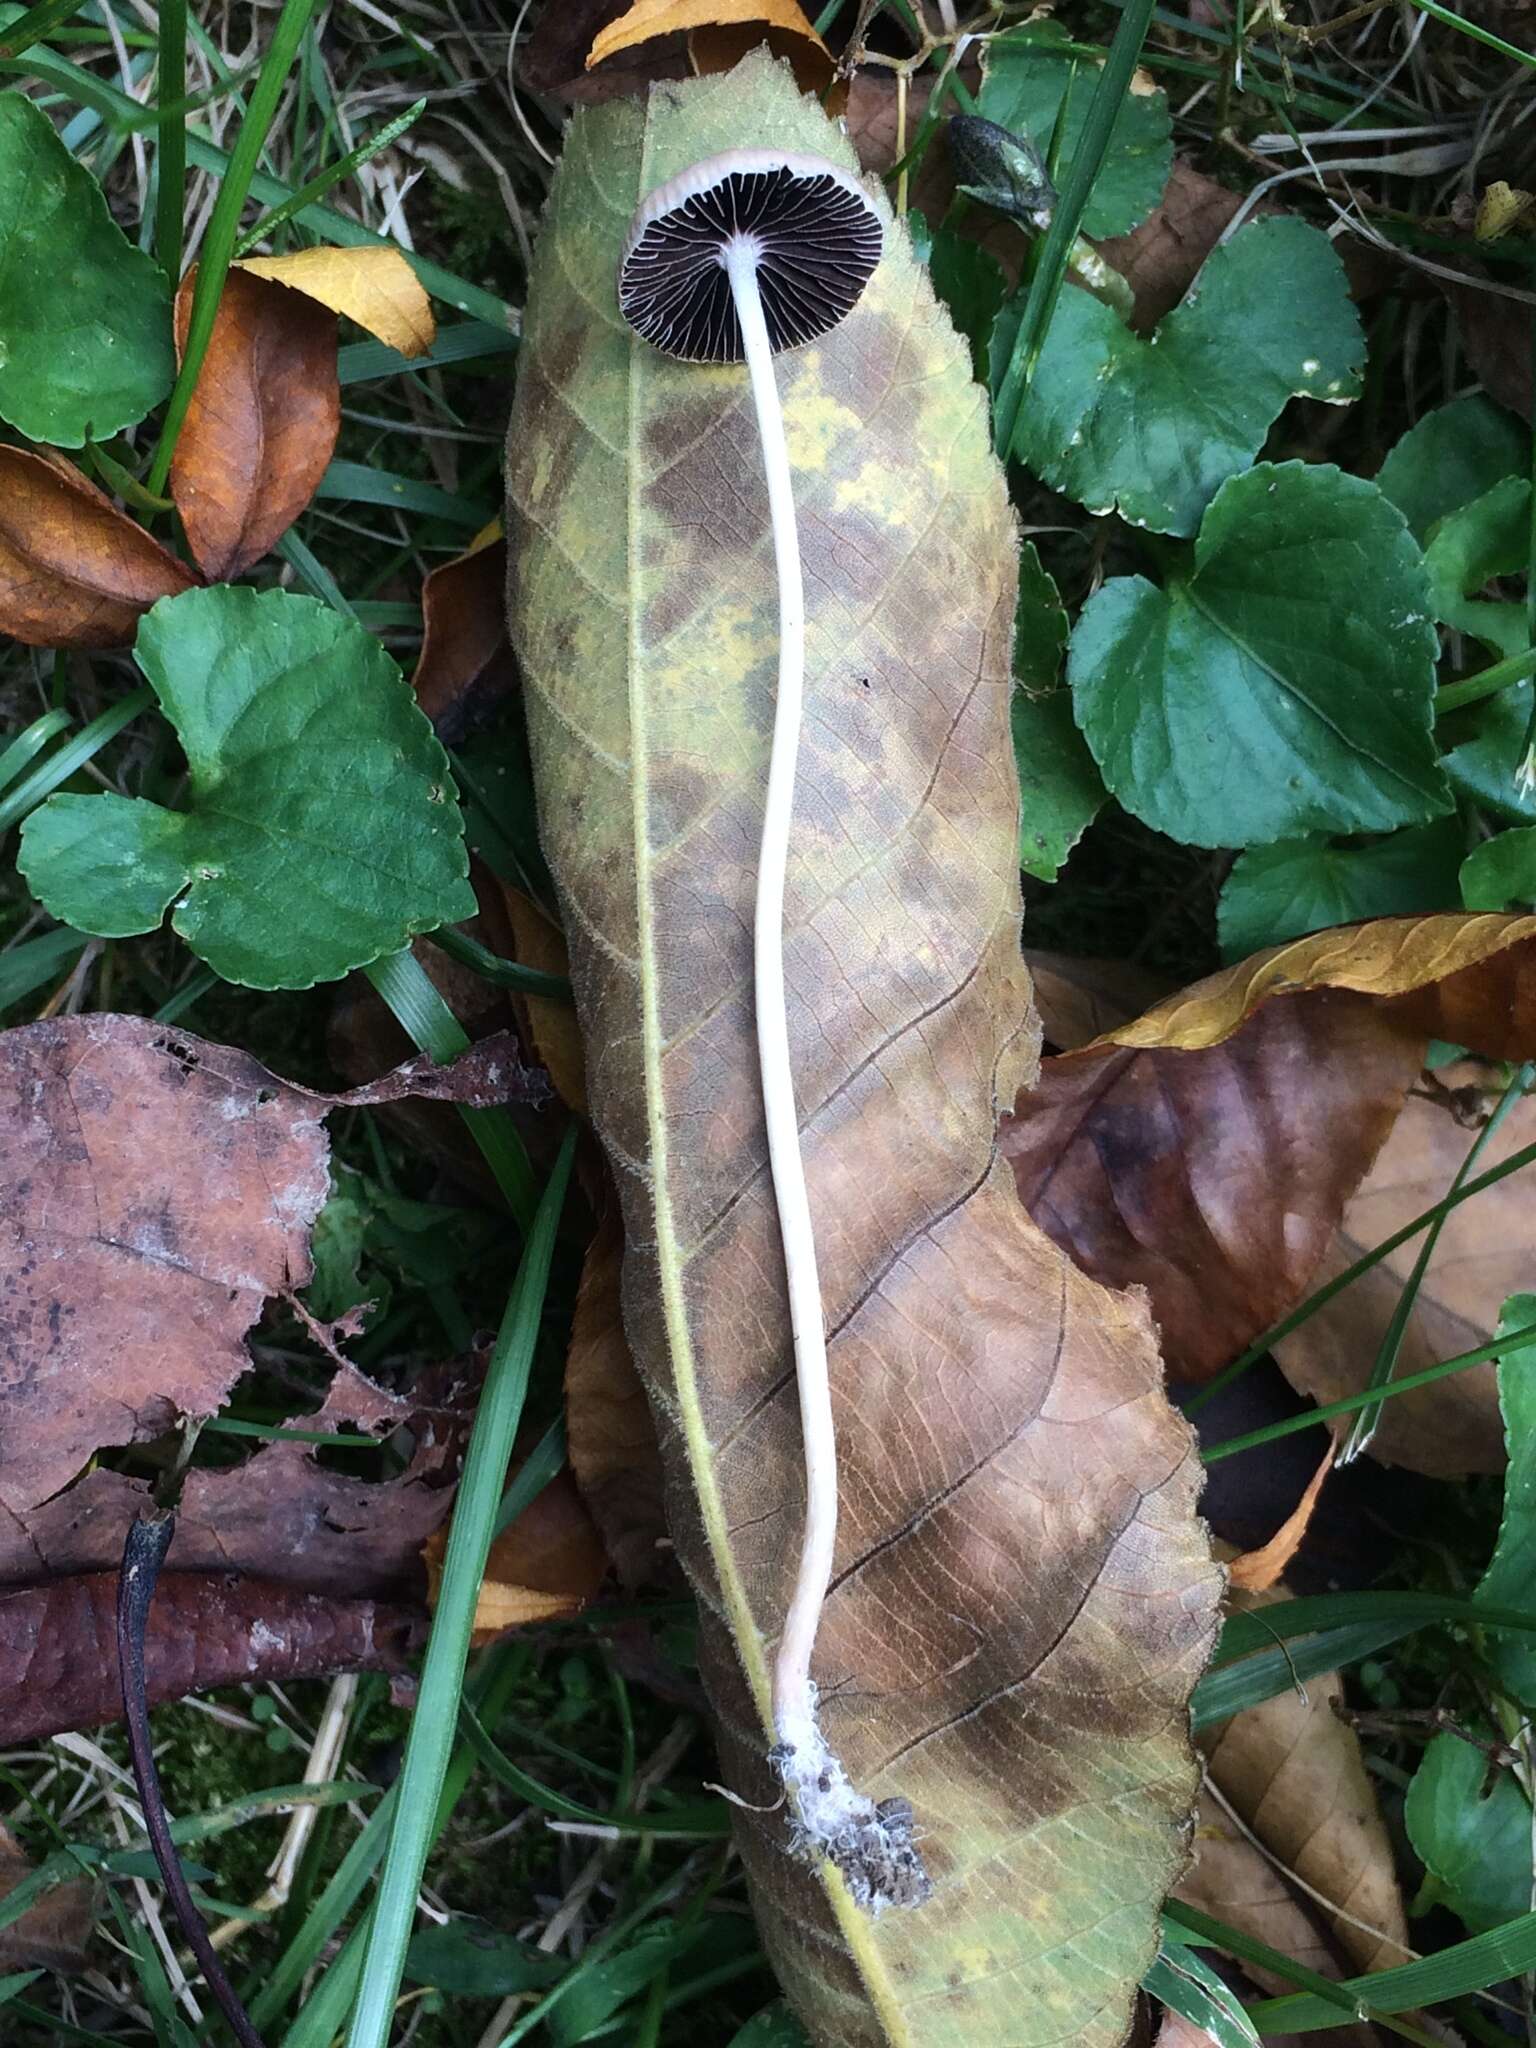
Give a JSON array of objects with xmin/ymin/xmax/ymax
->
[{"xmin": 1067, "ymin": 463, "xmax": 1450, "ymax": 846}]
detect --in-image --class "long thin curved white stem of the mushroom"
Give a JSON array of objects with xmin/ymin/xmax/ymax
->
[{"xmin": 725, "ymin": 240, "xmax": 838, "ymax": 1745}]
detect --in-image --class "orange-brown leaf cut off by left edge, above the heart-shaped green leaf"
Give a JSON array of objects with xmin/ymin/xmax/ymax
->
[{"xmin": 0, "ymin": 446, "xmax": 197, "ymax": 647}]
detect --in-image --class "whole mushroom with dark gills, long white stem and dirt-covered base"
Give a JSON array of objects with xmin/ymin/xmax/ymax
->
[{"xmin": 618, "ymin": 150, "xmax": 928, "ymax": 1911}]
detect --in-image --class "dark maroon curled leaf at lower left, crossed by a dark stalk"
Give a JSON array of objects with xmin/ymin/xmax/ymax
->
[{"xmin": 0, "ymin": 1564, "xmax": 426, "ymax": 1745}]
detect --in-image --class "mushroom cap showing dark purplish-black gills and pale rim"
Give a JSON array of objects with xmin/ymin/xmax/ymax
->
[{"xmin": 618, "ymin": 150, "xmax": 885, "ymax": 362}]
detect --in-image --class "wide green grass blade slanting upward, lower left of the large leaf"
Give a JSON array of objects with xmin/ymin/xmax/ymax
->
[{"xmin": 346, "ymin": 1124, "xmax": 575, "ymax": 2048}]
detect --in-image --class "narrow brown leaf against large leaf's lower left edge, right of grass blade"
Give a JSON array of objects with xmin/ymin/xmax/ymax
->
[{"xmin": 565, "ymin": 1206, "xmax": 668, "ymax": 1589}]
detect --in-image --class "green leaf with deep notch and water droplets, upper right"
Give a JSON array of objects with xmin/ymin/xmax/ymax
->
[{"xmin": 1015, "ymin": 219, "xmax": 1366, "ymax": 535}]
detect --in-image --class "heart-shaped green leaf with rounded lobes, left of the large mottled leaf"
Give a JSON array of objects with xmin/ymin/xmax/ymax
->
[{"xmin": 18, "ymin": 586, "xmax": 475, "ymax": 989}]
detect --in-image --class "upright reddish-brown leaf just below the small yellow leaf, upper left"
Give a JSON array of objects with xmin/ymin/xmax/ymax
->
[{"xmin": 170, "ymin": 268, "xmax": 342, "ymax": 582}]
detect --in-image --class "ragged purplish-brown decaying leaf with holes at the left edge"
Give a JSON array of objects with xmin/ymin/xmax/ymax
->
[{"xmin": 0, "ymin": 1016, "xmax": 536, "ymax": 1589}]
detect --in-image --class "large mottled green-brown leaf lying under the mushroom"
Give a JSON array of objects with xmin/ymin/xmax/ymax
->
[{"xmin": 508, "ymin": 57, "xmax": 1214, "ymax": 2048}]
